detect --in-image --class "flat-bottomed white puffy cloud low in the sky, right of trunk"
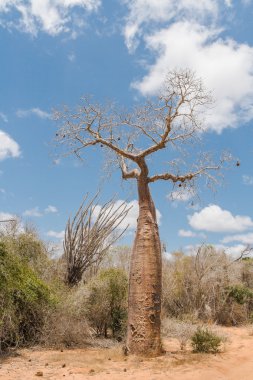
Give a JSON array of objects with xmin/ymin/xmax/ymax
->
[{"xmin": 188, "ymin": 205, "xmax": 253, "ymax": 232}]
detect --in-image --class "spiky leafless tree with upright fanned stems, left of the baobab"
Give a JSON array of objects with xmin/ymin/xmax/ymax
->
[{"xmin": 63, "ymin": 195, "xmax": 130, "ymax": 286}]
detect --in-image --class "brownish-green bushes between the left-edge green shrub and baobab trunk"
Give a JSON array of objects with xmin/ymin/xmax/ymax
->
[{"xmin": 41, "ymin": 268, "xmax": 128, "ymax": 347}]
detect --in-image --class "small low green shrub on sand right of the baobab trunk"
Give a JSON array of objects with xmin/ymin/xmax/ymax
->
[{"xmin": 191, "ymin": 327, "xmax": 222, "ymax": 354}]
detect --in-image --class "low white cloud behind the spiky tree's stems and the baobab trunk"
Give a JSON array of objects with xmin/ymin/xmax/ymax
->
[{"xmin": 94, "ymin": 200, "xmax": 162, "ymax": 230}]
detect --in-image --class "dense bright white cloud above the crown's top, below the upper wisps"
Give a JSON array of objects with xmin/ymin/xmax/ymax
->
[{"xmin": 133, "ymin": 21, "xmax": 253, "ymax": 133}]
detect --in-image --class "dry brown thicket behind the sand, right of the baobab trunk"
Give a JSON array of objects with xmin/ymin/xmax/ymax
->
[{"xmin": 163, "ymin": 246, "xmax": 253, "ymax": 325}]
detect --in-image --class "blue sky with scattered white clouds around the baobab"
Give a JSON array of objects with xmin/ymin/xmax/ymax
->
[{"xmin": 0, "ymin": 0, "xmax": 253, "ymax": 253}]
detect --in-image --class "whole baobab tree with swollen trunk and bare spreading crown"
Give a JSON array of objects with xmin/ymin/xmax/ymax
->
[{"xmin": 55, "ymin": 70, "xmax": 227, "ymax": 356}]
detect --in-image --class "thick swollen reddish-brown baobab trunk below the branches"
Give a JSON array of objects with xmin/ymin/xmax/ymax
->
[{"xmin": 127, "ymin": 176, "xmax": 162, "ymax": 356}]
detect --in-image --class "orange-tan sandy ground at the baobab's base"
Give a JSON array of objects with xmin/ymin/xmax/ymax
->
[{"xmin": 0, "ymin": 328, "xmax": 253, "ymax": 380}]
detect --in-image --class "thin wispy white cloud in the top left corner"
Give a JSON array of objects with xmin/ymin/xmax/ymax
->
[{"xmin": 0, "ymin": 0, "xmax": 101, "ymax": 36}]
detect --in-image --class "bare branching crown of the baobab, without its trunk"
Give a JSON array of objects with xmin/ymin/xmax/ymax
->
[{"xmin": 56, "ymin": 70, "xmax": 227, "ymax": 191}]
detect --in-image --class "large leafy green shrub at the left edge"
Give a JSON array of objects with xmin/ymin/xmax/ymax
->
[{"xmin": 0, "ymin": 242, "xmax": 55, "ymax": 350}]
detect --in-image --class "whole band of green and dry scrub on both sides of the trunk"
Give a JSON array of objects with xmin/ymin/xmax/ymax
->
[{"xmin": 0, "ymin": 218, "xmax": 253, "ymax": 352}]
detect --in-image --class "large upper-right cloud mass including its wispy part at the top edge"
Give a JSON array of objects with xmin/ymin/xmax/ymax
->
[{"xmin": 123, "ymin": 0, "xmax": 253, "ymax": 133}]
